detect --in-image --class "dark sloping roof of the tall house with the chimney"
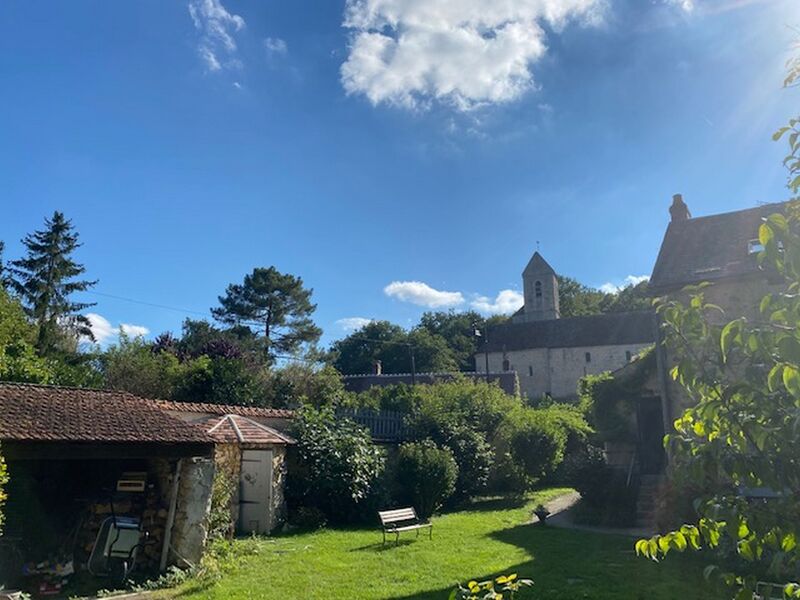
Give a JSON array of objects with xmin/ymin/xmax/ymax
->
[{"xmin": 650, "ymin": 202, "xmax": 785, "ymax": 292}]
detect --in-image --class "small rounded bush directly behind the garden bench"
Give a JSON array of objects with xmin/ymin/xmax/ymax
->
[{"xmin": 396, "ymin": 440, "xmax": 458, "ymax": 519}]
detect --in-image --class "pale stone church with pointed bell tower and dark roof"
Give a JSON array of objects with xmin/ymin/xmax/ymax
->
[{"xmin": 475, "ymin": 252, "xmax": 655, "ymax": 400}]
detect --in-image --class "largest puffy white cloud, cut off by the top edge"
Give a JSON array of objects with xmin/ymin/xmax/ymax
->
[{"xmin": 341, "ymin": 0, "xmax": 605, "ymax": 110}]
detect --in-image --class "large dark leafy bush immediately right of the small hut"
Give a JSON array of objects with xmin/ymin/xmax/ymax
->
[{"xmin": 286, "ymin": 408, "xmax": 383, "ymax": 523}]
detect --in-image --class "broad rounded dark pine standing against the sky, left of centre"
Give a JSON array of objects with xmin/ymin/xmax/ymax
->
[{"xmin": 216, "ymin": 267, "xmax": 322, "ymax": 358}]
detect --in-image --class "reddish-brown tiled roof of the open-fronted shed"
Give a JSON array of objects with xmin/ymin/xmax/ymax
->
[{"xmin": 0, "ymin": 383, "xmax": 214, "ymax": 443}]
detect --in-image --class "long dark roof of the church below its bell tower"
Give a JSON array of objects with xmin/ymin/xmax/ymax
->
[{"xmin": 478, "ymin": 311, "xmax": 655, "ymax": 353}]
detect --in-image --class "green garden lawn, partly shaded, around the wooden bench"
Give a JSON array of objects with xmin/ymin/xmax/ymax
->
[{"xmin": 169, "ymin": 490, "xmax": 719, "ymax": 600}]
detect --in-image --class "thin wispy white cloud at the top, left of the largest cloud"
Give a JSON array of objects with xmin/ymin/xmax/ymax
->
[{"xmin": 189, "ymin": 0, "xmax": 245, "ymax": 71}]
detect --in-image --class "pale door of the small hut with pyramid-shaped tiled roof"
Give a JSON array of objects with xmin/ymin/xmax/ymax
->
[{"xmin": 239, "ymin": 450, "xmax": 272, "ymax": 533}]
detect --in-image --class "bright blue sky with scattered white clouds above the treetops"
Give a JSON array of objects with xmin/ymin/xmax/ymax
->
[{"xmin": 0, "ymin": 0, "xmax": 800, "ymax": 350}]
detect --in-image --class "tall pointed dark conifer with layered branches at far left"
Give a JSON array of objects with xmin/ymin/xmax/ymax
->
[{"xmin": 9, "ymin": 211, "xmax": 97, "ymax": 355}]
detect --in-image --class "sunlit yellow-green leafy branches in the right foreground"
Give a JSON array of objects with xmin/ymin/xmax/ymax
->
[{"xmin": 636, "ymin": 203, "xmax": 800, "ymax": 598}]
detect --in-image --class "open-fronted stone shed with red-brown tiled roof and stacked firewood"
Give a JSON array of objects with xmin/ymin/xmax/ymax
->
[{"xmin": 0, "ymin": 383, "xmax": 215, "ymax": 582}]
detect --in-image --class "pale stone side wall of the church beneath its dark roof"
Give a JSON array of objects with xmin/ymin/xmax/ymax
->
[{"xmin": 475, "ymin": 344, "xmax": 652, "ymax": 400}]
